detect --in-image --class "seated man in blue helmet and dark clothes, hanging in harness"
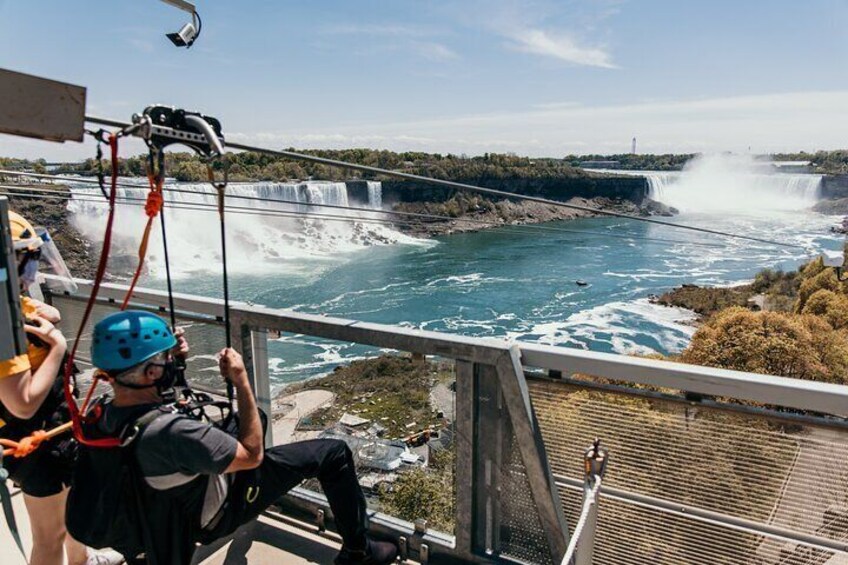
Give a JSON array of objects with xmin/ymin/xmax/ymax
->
[{"xmin": 86, "ymin": 311, "xmax": 397, "ymax": 564}]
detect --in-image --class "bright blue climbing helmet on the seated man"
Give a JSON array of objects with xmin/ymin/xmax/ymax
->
[{"xmin": 91, "ymin": 310, "xmax": 177, "ymax": 374}]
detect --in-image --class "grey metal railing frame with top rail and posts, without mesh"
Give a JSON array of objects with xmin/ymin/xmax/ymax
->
[{"xmin": 48, "ymin": 280, "xmax": 848, "ymax": 563}]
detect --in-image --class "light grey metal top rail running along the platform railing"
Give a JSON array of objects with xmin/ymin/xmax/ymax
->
[{"xmin": 51, "ymin": 279, "xmax": 848, "ymax": 416}]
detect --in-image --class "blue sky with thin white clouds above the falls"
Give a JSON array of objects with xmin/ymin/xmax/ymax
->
[{"xmin": 0, "ymin": 0, "xmax": 848, "ymax": 159}]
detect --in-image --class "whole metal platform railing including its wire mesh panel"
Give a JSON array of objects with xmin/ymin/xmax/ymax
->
[{"xmin": 48, "ymin": 281, "xmax": 848, "ymax": 565}]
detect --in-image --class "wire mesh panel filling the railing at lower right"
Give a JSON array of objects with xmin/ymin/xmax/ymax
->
[{"xmin": 530, "ymin": 376, "xmax": 848, "ymax": 565}]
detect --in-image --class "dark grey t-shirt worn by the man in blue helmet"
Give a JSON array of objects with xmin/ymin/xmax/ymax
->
[{"xmin": 101, "ymin": 405, "xmax": 238, "ymax": 528}]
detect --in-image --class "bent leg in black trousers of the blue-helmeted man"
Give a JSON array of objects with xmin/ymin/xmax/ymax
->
[{"xmin": 229, "ymin": 439, "xmax": 368, "ymax": 549}]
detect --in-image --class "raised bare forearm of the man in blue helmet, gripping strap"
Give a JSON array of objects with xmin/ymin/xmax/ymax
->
[{"xmin": 219, "ymin": 348, "xmax": 265, "ymax": 473}]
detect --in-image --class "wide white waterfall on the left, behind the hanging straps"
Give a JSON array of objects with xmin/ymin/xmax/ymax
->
[{"xmin": 68, "ymin": 181, "xmax": 415, "ymax": 276}]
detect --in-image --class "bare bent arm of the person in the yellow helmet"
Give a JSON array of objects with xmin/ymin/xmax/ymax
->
[{"xmin": 0, "ymin": 316, "xmax": 67, "ymax": 420}]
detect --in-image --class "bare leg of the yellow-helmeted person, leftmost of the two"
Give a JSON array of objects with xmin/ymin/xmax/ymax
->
[{"xmin": 24, "ymin": 492, "xmax": 67, "ymax": 565}]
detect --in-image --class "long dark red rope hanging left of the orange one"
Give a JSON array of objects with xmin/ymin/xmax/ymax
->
[{"xmin": 63, "ymin": 134, "xmax": 121, "ymax": 447}]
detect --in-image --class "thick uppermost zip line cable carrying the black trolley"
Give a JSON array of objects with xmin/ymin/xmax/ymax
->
[{"xmin": 85, "ymin": 116, "xmax": 806, "ymax": 249}]
